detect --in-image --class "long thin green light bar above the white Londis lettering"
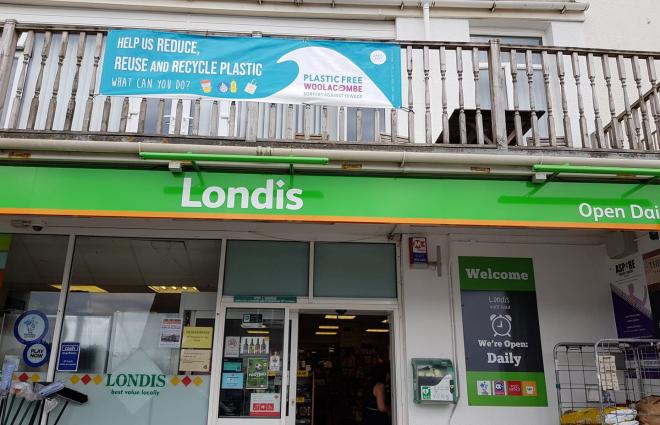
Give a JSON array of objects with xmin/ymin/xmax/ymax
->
[{"xmin": 140, "ymin": 152, "xmax": 330, "ymax": 165}]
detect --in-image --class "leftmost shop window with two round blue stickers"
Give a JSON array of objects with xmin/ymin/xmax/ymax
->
[{"xmin": 0, "ymin": 234, "xmax": 68, "ymax": 380}]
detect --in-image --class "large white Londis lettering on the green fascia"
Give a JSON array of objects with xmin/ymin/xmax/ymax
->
[{"xmin": 181, "ymin": 177, "xmax": 303, "ymax": 211}]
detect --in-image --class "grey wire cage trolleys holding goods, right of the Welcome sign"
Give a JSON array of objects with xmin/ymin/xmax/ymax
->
[{"xmin": 554, "ymin": 338, "xmax": 660, "ymax": 425}]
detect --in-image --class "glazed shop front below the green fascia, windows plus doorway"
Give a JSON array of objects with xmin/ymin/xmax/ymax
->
[{"xmin": 0, "ymin": 231, "xmax": 398, "ymax": 424}]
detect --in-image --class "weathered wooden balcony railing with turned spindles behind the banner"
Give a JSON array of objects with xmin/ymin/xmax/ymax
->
[{"xmin": 0, "ymin": 20, "xmax": 660, "ymax": 151}]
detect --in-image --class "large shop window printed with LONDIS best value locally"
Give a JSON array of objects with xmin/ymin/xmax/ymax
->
[{"xmin": 56, "ymin": 237, "xmax": 220, "ymax": 425}]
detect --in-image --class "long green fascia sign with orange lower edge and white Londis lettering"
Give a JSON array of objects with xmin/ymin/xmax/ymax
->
[{"xmin": 0, "ymin": 166, "xmax": 660, "ymax": 230}]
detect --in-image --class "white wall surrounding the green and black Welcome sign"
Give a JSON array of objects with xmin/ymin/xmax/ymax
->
[{"xmin": 402, "ymin": 231, "xmax": 616, "ymax": 425}]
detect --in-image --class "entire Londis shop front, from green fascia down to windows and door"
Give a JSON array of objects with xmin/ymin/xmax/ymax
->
[{"xmin": 0, "ymin": 166, "xmax": 660, "ymax": 425}]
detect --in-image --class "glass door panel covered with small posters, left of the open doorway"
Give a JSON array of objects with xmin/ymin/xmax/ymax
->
[{"xmin": 219, "ymin": 308, "xmax": 284, "ymax": 418}]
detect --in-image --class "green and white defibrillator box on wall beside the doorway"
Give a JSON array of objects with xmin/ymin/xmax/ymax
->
[{"xmin": 412, "ymin": 359, "xmax": 458, "ymax": 404}]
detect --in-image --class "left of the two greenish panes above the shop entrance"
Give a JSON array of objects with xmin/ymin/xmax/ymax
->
[{"xmin": 223, "ymin": 241, "xmax": 309, "ymax": 296}]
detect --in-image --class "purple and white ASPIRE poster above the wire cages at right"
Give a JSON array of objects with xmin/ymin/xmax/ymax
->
[{"xmin": 609, "ymin": 255, "xmax": 660, "ymax": 338}]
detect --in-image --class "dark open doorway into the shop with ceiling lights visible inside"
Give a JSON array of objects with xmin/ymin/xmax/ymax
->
[{"xmin": 296, "ymin": 312, "xmax": 391, "ymax": 425}]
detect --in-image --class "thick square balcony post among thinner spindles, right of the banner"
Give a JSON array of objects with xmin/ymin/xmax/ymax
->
[{"xmin": 488, "ymin": 40, "xmax": 508, "ymax": 149}]
